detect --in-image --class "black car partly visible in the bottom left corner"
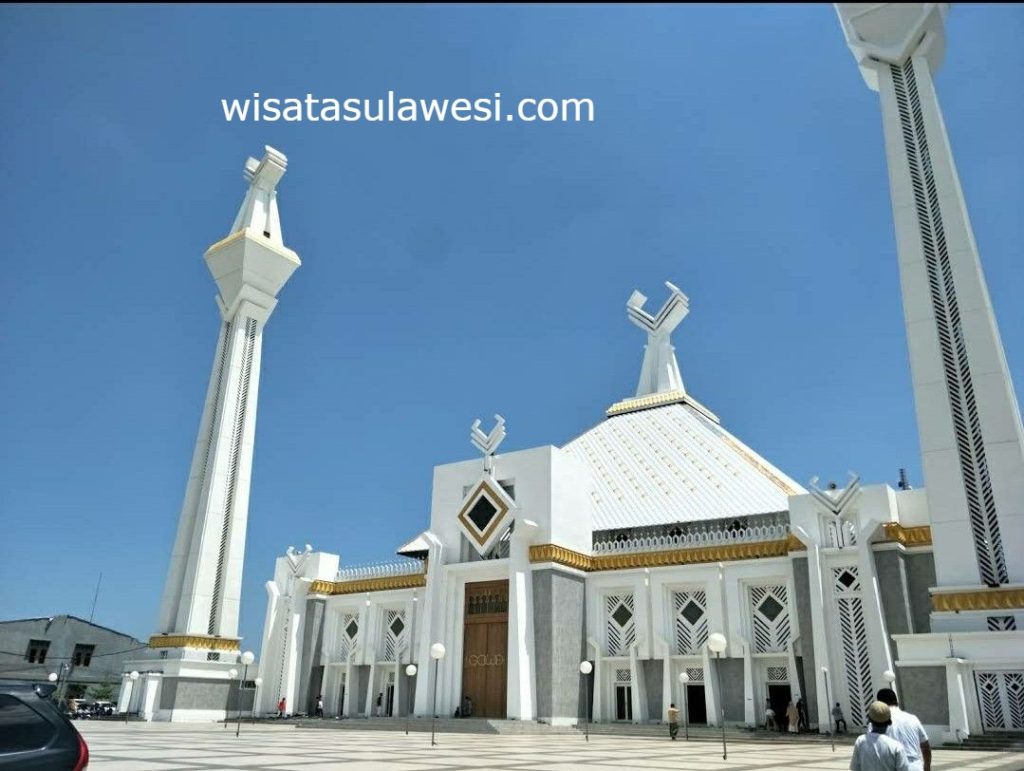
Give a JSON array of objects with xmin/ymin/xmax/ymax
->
[{"xmin": 0, "ymin": 682, "xmax": 89, "ymax": 771}]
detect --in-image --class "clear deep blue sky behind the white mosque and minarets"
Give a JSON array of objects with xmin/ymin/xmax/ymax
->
[{"xmin": 0, "ymin": 5, "xmax": 1024, "ymax": 647}]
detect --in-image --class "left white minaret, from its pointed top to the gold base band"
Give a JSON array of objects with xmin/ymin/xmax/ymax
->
[{"xmin": 150, "ymin": 147, "xmax": 301, "ymax": 660}]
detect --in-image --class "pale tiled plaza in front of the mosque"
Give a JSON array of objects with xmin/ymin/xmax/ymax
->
[{"xmin": 79, "ymin": 722, "xmax": 1024, "ymax": 771}]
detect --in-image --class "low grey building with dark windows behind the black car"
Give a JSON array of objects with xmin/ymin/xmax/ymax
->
[{"xmin": 0, "ymin": 615, "xmax": 146, "ymax": 698}]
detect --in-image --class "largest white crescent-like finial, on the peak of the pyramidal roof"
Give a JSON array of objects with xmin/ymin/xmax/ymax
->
[{"xmin": 626, "ymin": 282, "xmax": 690, "ymax": 396}]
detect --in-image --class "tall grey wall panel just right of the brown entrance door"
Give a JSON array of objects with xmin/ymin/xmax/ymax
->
[{"xmin": 534, "ymin": 568, "xmax": 586, "ymax": 720}]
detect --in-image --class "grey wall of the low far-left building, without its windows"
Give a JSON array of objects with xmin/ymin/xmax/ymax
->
[{"xmin": 0, "ymin": 615, "xmax": 153, "ymax": 700}]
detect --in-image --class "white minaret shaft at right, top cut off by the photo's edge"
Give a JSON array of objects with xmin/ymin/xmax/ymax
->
[{"xmin": 837, "ymin": 3, "xmax": 1024, "ymax": 602}]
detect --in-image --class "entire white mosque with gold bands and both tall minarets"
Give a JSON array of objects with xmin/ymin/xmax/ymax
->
[{"xmin": 123, "ymin": 3, "xmax": 1024, "ymax": 741}]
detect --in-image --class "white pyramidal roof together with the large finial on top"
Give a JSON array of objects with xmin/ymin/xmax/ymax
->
[{"xmin": 562, "ymin": 284, "xmax": 806, "ymax": 530}]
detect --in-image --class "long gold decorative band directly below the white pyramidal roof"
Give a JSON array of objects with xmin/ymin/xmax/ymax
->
[{"xmin": 529, "ymin": 538, "xmax": 799, "ymax": 572}]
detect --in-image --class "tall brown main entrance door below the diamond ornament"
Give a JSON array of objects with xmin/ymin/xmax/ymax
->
[{"xmin": 460, "ymin": 581, "xmax": 509, "ymax": 718}]
